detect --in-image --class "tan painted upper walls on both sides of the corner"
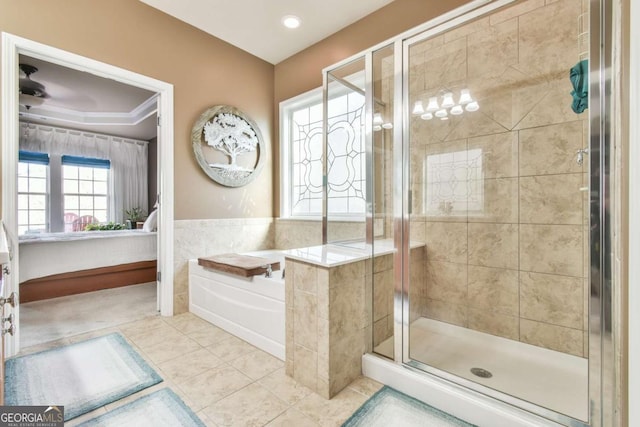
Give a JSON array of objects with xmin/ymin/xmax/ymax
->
[{"xmin": 0, "ymin": 0, "xmax": 476, "ymax": 220}]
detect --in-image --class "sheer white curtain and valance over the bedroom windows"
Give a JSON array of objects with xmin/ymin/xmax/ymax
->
[{"xmin": 20, "ymin": 123, "xmax": 149, "ymax": 222}]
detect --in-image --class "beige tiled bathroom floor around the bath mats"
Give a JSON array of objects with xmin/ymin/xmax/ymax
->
[{"xmin": 21, "ymin": 313, "xmax": 382, "ymax": 427}]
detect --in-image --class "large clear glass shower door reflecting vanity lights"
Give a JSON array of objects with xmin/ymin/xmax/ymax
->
[{"xmin": 402, "ymin": 0, "xmax": 590, "ymax": 425}]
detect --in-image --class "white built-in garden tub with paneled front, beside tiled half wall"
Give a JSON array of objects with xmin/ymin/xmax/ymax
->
[{"xmin": 189, "ymin": 250, "xmax": 285, "ymax": 360}]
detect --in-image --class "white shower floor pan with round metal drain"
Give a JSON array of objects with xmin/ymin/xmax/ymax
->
[{"xmin": 374, "ymin": 318, "xmax": 589, "ymax": 420}]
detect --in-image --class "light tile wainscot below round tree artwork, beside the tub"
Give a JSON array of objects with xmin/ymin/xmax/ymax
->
[{"xmin": 173, "ymin": 218, "xmax": 275, "ymax": 314}]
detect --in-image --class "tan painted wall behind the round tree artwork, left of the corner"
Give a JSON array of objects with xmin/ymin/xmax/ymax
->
[{"xmin": 0, "ymin": 0, "xmax": 274, "ymax": 220}]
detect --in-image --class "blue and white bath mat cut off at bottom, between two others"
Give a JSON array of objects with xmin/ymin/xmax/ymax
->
[{"xmin": 78, "ymin": 388, "xmax": 205, "ymax": 427}]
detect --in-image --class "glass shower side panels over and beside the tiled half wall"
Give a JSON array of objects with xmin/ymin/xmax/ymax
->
[{"xmin": 317, "ymin": 44, "xmax": 402, "ymax": 359}]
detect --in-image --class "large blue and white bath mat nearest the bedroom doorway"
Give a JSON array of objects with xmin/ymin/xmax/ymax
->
[{"xmin": 5, "ymin": 333, "xmax": 162, "ymax": 421}]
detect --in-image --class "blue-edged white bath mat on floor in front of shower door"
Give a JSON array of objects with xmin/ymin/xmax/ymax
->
[{"xmin": 342, "ymin": 386, "xmax": 473, "ymax": 427}]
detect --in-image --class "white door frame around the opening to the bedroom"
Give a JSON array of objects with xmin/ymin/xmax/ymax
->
[{"xmin": 0, "ymin": 32, "xmax": 174, "ymax": 357}]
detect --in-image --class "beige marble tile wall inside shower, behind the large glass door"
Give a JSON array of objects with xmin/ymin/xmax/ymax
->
[{"xmin": 409, "ymin": 0, "xmax": 589, "ymax": 356}]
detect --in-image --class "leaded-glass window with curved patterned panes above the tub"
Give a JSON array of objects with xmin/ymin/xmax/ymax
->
[{"xmin": 283, "ymin": 93, "xmax": 366, "ymax": 217}]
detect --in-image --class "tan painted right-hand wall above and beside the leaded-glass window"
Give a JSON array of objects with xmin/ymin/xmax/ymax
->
[{"xmin": 273, "ymin": 0, "xmax": 469, "ymax": 217}]
